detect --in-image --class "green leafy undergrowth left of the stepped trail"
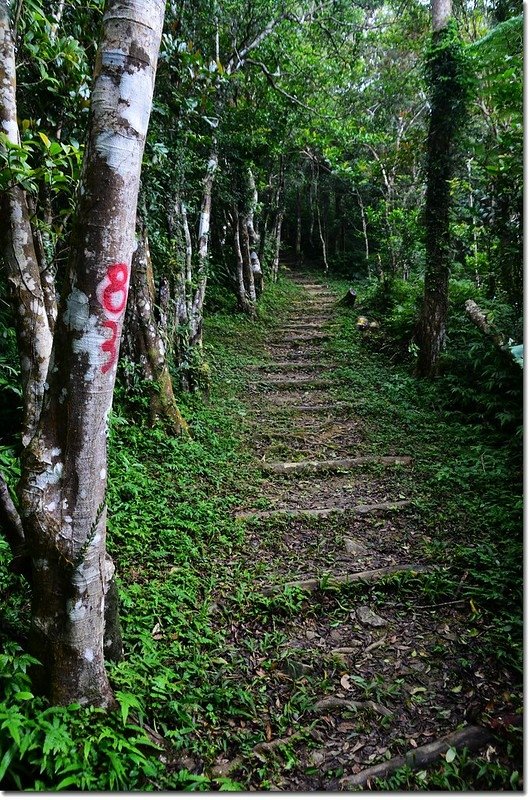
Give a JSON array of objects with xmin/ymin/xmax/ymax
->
[{"xmin": 0, "ymin": 281, "xmax": 304, "ymax": 791}]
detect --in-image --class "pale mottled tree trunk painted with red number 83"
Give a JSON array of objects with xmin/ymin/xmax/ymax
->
[{"xmin": 0, "ymin": 0, "xmax": 165, "ymax": 706}]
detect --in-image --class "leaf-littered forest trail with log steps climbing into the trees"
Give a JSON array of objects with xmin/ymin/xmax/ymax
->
[{"xmin": 204, "ymin": 273, "xmax": 516, "ymax": 791}]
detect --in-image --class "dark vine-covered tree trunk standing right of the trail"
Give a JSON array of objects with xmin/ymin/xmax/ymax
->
[{"xmin": 416, "ymin": 0, "xmax": 466, "ymax": 377}]
